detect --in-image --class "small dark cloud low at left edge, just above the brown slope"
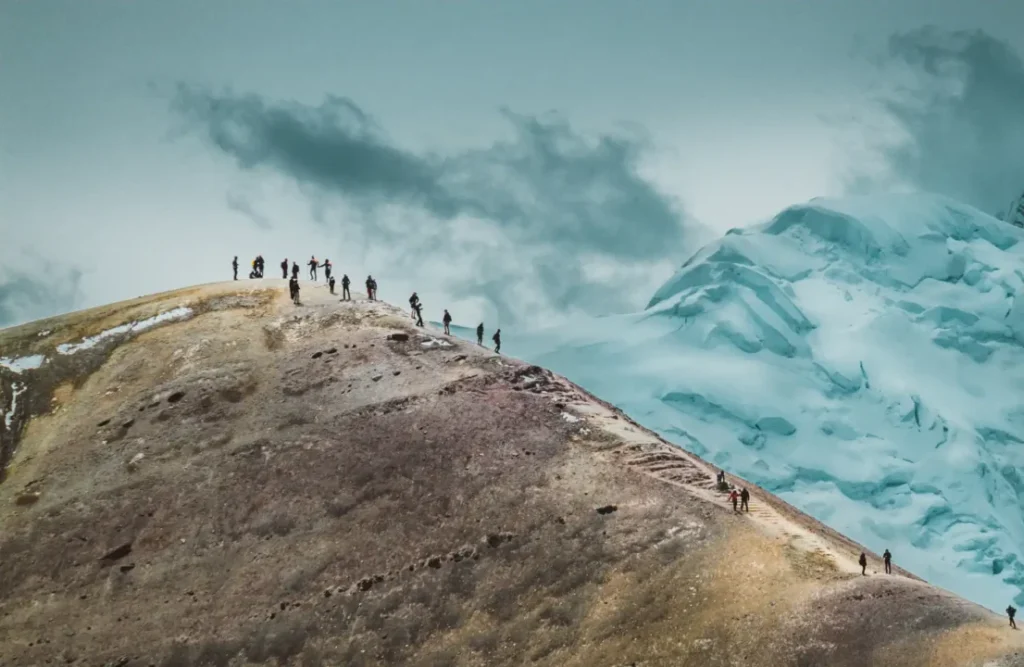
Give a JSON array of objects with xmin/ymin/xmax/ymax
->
[{"xmin": 0, "ymin": 264, "xmax": 82, "ymax": 327}]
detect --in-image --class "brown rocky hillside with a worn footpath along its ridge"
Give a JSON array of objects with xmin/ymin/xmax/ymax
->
[{"xmin": 0, "ymin": 281, "xmax": 1024, "ymax": 667}]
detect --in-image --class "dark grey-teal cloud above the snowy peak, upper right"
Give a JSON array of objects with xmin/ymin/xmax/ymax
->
[{"xmin": 856, "ymin": 28, "xmax": 1024, "ymax": 213}]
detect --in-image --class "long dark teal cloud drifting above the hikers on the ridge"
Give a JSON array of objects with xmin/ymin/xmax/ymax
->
[{"xmin": 173, "ymin": 85, "xmax": 693, "ymax": 321}]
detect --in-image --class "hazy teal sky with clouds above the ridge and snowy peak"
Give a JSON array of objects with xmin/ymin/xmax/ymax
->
[{"xmin": 0, "ymin": 0, "xmax": 1024, "ymax": 328}]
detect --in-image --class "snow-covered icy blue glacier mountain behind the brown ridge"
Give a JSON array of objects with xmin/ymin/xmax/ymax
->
[{"xmin": 468, "ymin": 194, "xmax": 1024, "ymax": 610}]
